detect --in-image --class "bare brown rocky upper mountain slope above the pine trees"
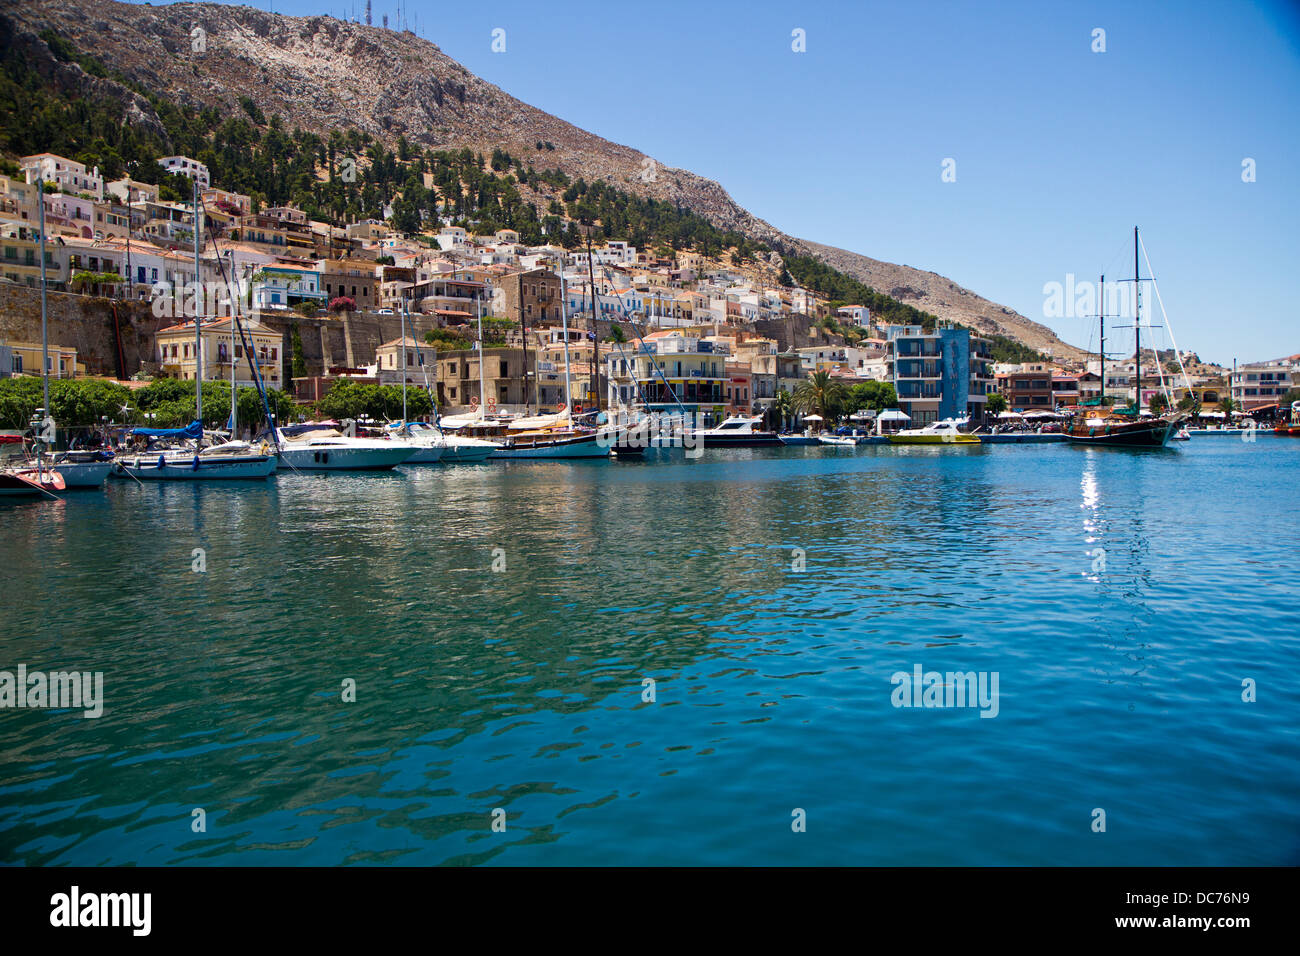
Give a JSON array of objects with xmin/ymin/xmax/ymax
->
[{"xmin": 10, "ymin": 0, "xmax": 1082, "ymax": 358}]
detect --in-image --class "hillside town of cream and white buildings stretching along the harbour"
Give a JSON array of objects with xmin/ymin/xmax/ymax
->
[{"xmin": 0, "ymin": 153, "xmax": 1279, "ymax": 425}]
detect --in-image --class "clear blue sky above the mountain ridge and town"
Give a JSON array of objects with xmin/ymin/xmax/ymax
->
[{"xmin": 137, "ymin": 0, "xmax": 1300, "ymax": 363}]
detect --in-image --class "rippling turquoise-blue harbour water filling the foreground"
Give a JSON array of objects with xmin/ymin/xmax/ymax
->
[{"xmin": 0, "ymin": 436, "xmax": 1300, "ymax": 865}]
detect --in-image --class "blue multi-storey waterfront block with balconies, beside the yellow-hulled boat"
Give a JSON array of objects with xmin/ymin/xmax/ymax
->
[{"xmin": 885, "ymin": 325, "xmax": 993, "ymax": 425}]
